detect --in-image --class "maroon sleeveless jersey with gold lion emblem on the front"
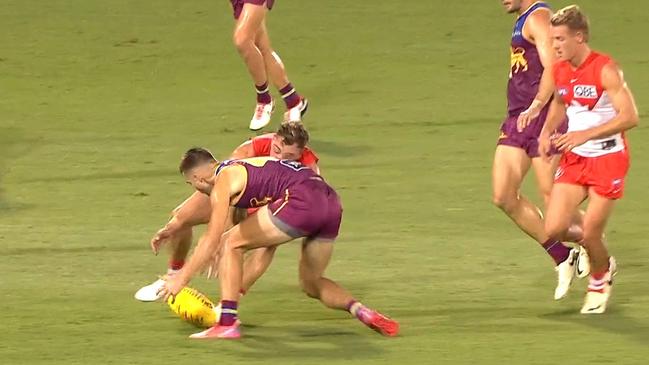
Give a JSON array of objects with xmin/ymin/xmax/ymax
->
[{"xmin": 507, "ymin": 1, "xmax": 549, "ymax": 117}]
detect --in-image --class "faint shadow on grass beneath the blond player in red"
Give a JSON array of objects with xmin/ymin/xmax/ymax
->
[{"xmin": 539, "ymin": 305, "xmax": 649, "ymax": 344}]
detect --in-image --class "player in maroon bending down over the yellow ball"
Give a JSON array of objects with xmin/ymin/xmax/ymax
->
[{"xmin": 161, "ymin": 149, "xmax": 399, "ymax": 338}]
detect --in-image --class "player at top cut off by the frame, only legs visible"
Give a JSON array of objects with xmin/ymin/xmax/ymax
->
[{"xmin": 230, "ymin": 0, "xmax": 309, "ymax": 131}]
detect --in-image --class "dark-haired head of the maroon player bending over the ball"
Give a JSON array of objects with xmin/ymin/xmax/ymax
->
[{"xmin": 178, "ymin": 147, "xmax": 219, "ymax": 194}]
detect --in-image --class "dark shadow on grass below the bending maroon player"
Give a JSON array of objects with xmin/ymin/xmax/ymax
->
[{"xmin": 213, "ymin": 323, "xmax": 390, "ymax": 363}]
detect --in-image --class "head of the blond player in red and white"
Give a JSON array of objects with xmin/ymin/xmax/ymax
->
[{"xmin": 550, "ymin": 5, "xmax": 589, "ymax": 60}]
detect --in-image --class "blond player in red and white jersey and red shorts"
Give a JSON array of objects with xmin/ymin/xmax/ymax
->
[{"xmin": 539, "ymin": 5, "xmax": 638, "ymax": 314}]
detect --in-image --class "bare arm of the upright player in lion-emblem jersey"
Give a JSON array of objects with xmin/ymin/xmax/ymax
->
[{"xmin": 518, "ymin": 9, "xmax": 556, "ymax": 131}]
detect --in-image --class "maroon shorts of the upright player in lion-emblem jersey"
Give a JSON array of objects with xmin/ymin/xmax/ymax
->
[{"xmin": 498, "ymin": 108, "xmax": 568, "ymax": 158}]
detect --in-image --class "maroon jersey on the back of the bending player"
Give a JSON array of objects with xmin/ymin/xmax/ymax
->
[{"xmin": 217, "ymin": 157, "xmax": 322, "ymax": 208}]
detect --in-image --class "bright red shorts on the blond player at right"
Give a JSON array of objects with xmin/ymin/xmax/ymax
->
[{"xmin": 554, "ymin": 149, "xmax": 629, "ymax": 199}]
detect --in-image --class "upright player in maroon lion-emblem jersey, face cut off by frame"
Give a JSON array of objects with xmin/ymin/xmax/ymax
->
[{"xmin": 492, "ymin": 0, "xmax": 581, "ymax": 299}]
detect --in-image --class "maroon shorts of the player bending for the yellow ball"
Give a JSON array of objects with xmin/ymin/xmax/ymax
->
[{"xmin": 268, "ymin": 179, "xmax": 343, "ymax": 241}]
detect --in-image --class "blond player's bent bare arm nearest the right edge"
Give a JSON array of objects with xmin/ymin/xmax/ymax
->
[{"xmin": 555, "ymin": 63, "xmax": 639, "ymax": 150}]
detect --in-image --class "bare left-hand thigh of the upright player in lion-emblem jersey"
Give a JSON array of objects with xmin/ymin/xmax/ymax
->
[{"xmin": 492, "ymin": 145, "xmax": 531, "ymax": 197}]
